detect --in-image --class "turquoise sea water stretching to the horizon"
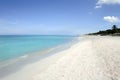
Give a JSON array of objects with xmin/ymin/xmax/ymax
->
[{"xmin": 0, "ymin": 35, "xmax": 73, "ymax": 61}]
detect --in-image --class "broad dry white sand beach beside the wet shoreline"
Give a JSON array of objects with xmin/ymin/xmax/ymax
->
[{"xmin": 0, "ymin": 36, "xmax": 120, "ymax": 80}]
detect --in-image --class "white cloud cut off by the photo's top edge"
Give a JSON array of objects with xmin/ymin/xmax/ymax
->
[{"xmin": 95, "ymin": 0, "xmax": 120, "ymax": 8}]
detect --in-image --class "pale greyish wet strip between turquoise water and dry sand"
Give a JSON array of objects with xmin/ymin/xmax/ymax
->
[{"xmin": 0, "ymin": 37, "xmax": 78, "ymax": 79}]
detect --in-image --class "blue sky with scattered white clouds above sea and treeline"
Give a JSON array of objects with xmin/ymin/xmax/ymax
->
[{"xmin": 0, "ymin": 0, "xmax": 120, "ymax": 35}]
